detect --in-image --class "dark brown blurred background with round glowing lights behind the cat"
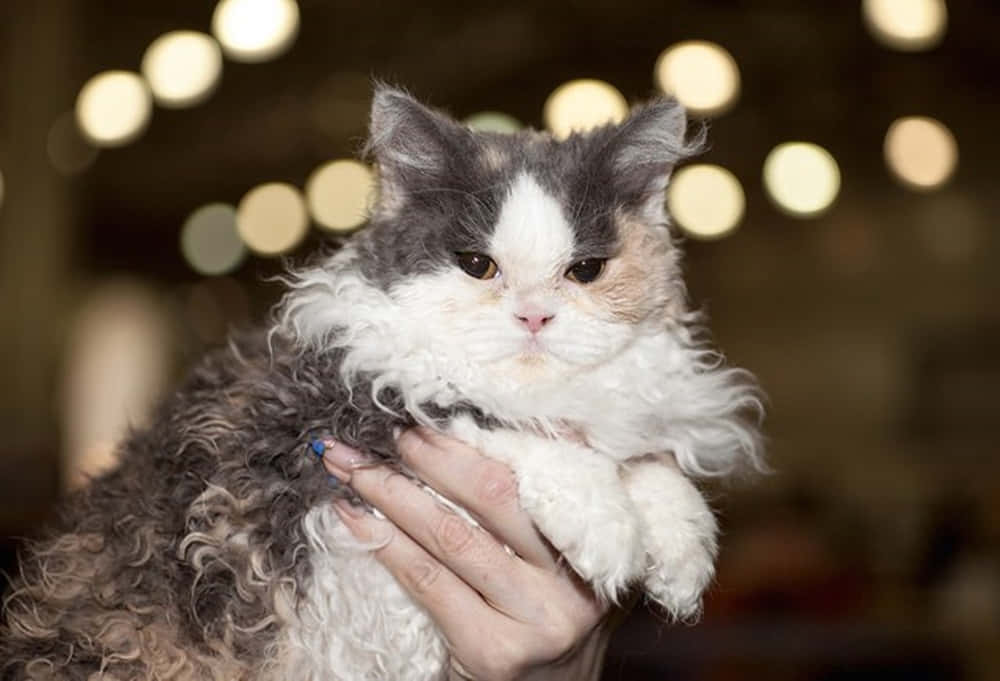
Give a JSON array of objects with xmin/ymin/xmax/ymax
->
[{"xmin": 0, "ymin": 0, "xmax": 1000, "ymax": 680}]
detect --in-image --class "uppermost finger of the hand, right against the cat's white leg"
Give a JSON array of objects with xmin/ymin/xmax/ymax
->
[{"xmin": 396, "ymin": 428, "xmax": 558, "ymax": 571}]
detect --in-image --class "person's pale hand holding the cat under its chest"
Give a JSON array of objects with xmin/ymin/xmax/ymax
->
[{"xmin": 323, "ymin": 428, "xmax": 620, "ymax": 681}]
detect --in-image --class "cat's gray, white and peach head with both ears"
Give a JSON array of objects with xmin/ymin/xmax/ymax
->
[{"xmin": 284, "ymin": 86, "xmax": 701, "ymax": 394}]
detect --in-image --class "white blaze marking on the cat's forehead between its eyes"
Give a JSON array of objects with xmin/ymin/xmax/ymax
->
[{"xmin": 490, "ymin": 172, "xmax": 576, "ymax": 285}]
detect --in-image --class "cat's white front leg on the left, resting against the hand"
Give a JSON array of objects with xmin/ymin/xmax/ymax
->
[{"xmin": 449, "ymin": 418, "xmax": 646, "ymax": 602}]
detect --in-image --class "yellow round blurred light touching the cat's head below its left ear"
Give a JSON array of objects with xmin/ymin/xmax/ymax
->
[{"xmin": 306, "ymin": 160, "xmax": 375, "ymax": 232}]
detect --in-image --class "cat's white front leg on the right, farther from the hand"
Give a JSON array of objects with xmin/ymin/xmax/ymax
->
[{"xmin": 624, "ymin": 455, "xmax": 718, "ymax": 619}]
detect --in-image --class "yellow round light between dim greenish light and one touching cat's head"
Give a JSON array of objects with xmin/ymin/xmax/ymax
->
[{"xmin": 236, "ymin": 182, "xmax": 309, "ymax": 255}]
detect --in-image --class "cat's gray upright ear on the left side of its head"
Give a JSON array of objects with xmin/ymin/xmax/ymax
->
[{"xmin": 366, "ymin": 83, "xmax": 470, "ymax": 205}]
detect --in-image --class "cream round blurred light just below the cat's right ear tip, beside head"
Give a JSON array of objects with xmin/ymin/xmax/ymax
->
[{"xmin": 667, "ymin": 163, "xmax": 746, "ymax": 239}]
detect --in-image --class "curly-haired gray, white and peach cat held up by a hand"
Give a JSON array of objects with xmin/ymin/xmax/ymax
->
[{"xmin": 0, "ymin": 85, "xmax": 762, "ymax": 681}]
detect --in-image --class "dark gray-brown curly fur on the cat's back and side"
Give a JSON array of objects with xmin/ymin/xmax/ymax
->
[{"xmin": 0, "ymin": 333, "xmax": 409, "ymax": 681}]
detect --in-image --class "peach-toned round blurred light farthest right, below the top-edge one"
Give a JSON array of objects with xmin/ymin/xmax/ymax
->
[{"xmin": 884, "ymin": 116, "xmax": 958, "ymax": 190}]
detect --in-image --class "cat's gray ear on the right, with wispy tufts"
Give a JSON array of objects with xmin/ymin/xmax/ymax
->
[{"xmin": 609, "ymin": 98, "xmax": 705, "ymax": 222}]
